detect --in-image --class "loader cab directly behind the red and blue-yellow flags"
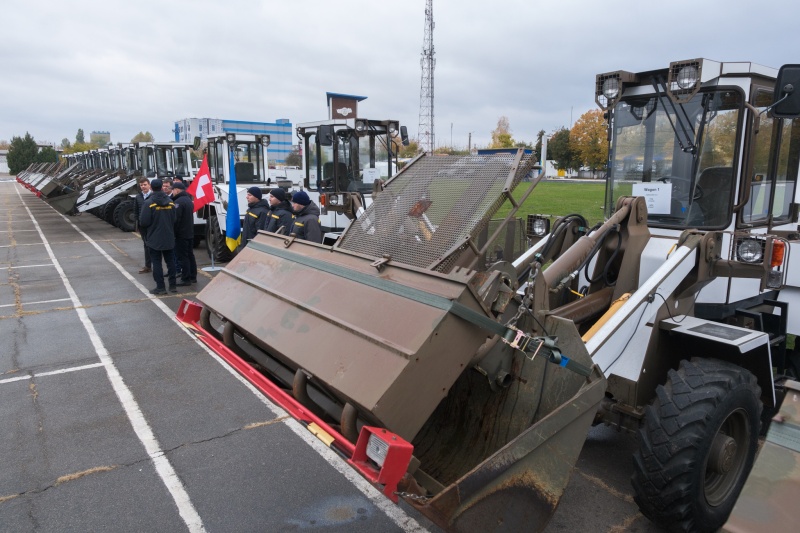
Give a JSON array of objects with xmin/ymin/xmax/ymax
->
[{"xmin": 207, "ymin": 133, "xmax": 270, "ymax": 186}]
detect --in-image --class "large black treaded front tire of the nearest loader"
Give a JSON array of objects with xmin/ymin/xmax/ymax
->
[{"xmin": 631, "ymin": 358, "xmax": 762, "ymax": 531}]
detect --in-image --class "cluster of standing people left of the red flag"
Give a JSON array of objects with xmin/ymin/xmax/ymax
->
[{"xmin": 134, "ymin": 177, "xmax": 197, "ymax": 295}]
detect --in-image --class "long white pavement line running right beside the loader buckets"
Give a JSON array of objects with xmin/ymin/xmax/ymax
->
[{"xmin": 42, "ymin": 193, "xmax": 428, "ymax": 533}]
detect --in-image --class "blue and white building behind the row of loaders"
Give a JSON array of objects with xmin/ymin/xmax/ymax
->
[{"xmin": 173, "ymin": 118, "xmax": 294, "ymax": 163}]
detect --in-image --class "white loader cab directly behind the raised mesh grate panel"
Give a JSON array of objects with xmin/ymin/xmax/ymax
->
[{"xmin": 297, "ymin": 118, "xmax": 408, "ymax": 215}]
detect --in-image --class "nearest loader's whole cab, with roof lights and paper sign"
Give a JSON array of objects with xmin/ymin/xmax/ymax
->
[{"xmin": 595, "ymin": 59, "xmax": 800, "ymax": 231}]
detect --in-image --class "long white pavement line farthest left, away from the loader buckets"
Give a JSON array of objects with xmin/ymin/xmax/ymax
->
[{"xmin": 16, "ymin": 188, "xmax": 205, "ymax": 533}]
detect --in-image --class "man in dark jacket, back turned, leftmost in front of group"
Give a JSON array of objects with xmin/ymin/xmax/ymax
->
[{"xmin": 139, "ymin": 178, "xmax": 178, "ymax": 294}]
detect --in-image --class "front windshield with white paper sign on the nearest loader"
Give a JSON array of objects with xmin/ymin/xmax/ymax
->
[{"xmin": 606, "ymin": 89, "xmax": 742, "ymax": 228}]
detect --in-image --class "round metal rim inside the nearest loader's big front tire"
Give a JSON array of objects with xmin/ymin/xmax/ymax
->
[{"xmin": 704, "ymin": 409, "xmax": 750, "ymax": 507}]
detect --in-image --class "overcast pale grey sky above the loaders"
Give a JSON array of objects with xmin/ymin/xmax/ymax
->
[{"xmin": 0, "ymin": 0, "xmax": 800, "ymax": 147}]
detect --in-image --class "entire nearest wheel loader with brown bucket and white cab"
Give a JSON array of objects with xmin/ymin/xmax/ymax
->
[{"xmin": 178, "ymin": 59, "xmax": 800, "ymax": 531}]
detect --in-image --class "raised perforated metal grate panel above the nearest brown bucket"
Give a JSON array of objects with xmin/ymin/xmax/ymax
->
[{"xmin": 338, "ymin": 153, "xmax": 534, "ymax": 272}]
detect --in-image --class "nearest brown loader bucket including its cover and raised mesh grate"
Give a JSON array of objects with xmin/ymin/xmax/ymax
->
[{"xmin": 189, "ymin": 153, "xmax": 605, "ymax": 531}]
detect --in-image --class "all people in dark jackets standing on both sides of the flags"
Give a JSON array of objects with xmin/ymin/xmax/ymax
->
[{"xmin": 134, "ymin": 177, "xmax": 322, "ymax": 295}]
